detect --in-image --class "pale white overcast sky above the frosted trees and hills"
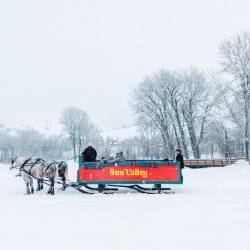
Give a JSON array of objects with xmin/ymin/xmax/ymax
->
[{"xmin": 0, "ymin": 0, "xmax": 250, "ymax": 133}]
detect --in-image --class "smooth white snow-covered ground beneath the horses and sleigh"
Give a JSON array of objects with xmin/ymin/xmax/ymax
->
[{"xmin": 0, "ymin": 161, "xmax": 250, "ymax": 250}]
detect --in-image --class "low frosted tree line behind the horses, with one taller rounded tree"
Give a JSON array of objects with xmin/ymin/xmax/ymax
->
[{"xmin": 0, "ymin": 107, "xmax": 121, "ymax": 161}]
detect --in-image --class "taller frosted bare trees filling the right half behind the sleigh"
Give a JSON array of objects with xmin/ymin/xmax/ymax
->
[{"xmin": 132, "ymin": 32, "xmax": 250, "ymax": 159}]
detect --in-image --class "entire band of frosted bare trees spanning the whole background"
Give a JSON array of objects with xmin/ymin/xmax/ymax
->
[{"xmin": 0, "ymin": 32, "xmax": 250, "ymax": 160}]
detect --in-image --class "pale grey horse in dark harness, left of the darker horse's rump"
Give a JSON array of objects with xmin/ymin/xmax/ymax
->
[{"xmin": 11, "ymin": 156, "xmax": 57, "ymax": 195}]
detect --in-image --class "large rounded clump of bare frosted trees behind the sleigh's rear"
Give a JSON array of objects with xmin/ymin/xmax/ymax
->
[{"xmin": 134, "ymin": 67, "xmax": 214, "ymax": 158}]
